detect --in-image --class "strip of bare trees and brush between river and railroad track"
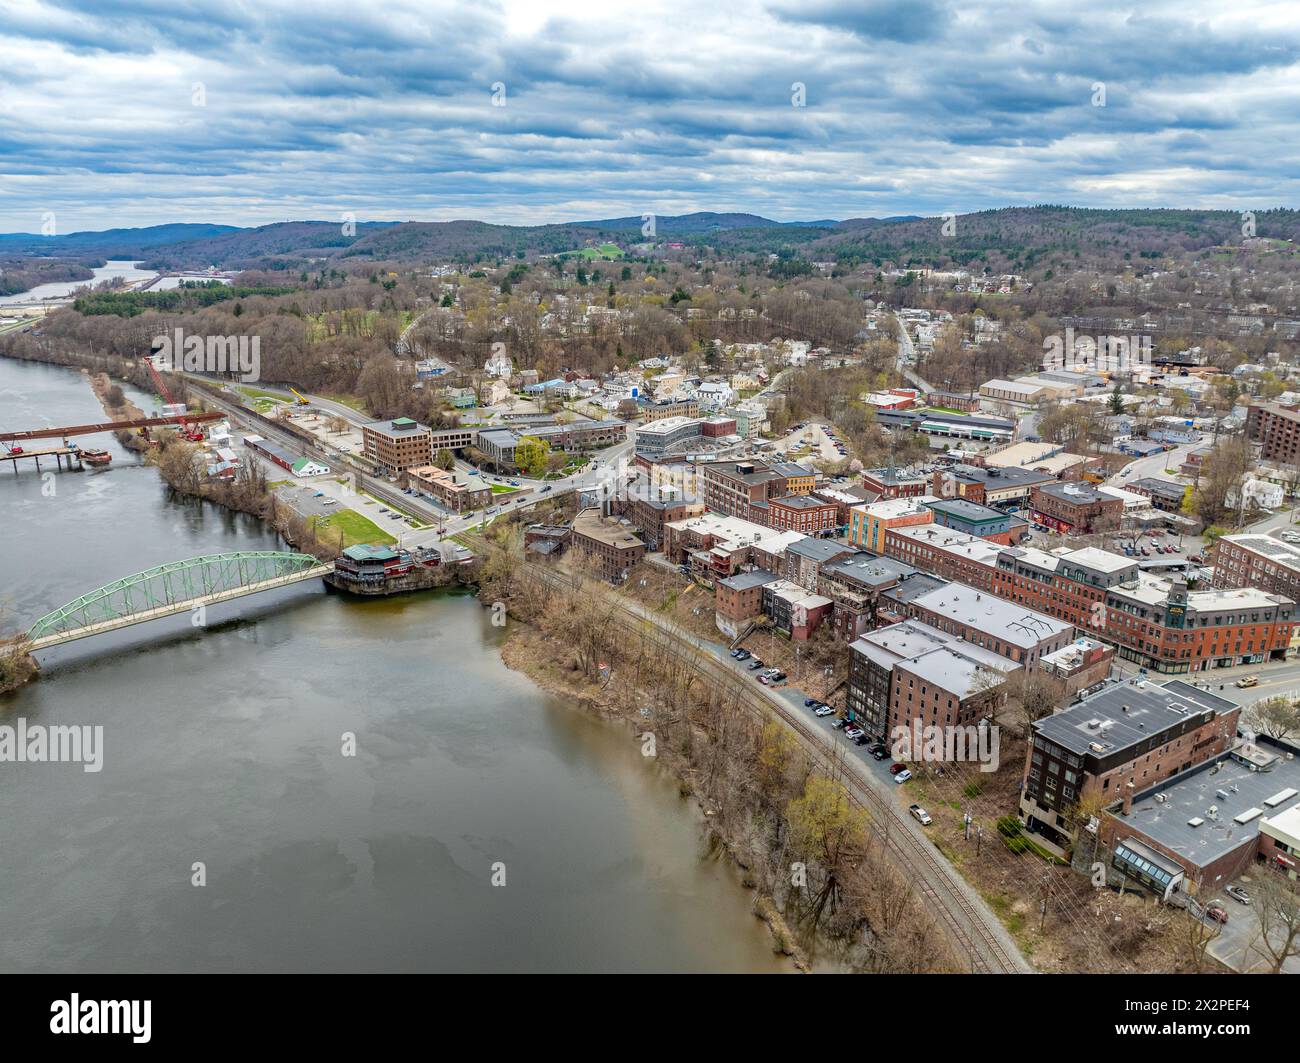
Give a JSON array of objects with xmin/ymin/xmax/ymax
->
[{"xmin": 480, "ymin": 550, "xmax": 965, "ymax": 973}]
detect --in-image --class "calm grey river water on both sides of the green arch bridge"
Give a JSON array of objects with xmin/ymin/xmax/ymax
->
[{"xmin": 0, "ymin": 359, "xmax": 788, "ymax": 972}]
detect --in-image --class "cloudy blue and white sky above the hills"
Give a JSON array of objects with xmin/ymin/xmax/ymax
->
[{"xmin": 0, "ymin": 0, "xmax": 1300, "ymax": 233}]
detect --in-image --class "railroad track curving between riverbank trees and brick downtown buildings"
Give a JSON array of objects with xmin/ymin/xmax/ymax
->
[{"xmin": 486, "ymin": 550, "xmax": 1032, "ymax": 973}]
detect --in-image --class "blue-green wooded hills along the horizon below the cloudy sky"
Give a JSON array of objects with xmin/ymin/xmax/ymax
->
[{"xmin": 0, "ymin": 205, "xmax": 1300, "ymax": 270}]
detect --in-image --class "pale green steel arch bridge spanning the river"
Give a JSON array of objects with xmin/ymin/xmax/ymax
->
[{"xmin": 27, "ymin": 550, "xmax": 333, "ymax": 650}]
